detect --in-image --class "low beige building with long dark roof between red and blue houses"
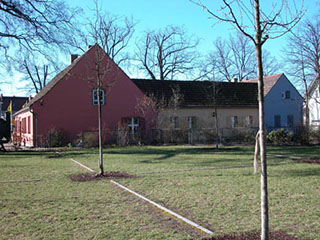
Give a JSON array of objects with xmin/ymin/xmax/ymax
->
[{"xmin": 132, "ymin": 79, "xmax": 258, "ymax": 143}]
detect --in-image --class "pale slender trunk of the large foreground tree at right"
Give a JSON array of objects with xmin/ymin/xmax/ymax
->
[{"xmin": 254, "ymin": 0, "xmax": 269, "ymax": 240}]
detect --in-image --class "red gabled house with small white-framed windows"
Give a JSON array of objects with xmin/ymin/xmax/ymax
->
[{"xmin": 14, "ymin": 44, "xmax": 156, "ymax": 146}]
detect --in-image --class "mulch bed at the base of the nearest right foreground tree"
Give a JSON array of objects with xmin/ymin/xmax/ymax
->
[{"xmin": 202, "ymin": 231, "xmax": 311, "ymax": 240}]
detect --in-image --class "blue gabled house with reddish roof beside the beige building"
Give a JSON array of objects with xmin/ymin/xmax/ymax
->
[{"xmin": 242, "ymin": 73, "xmax": 303, "ymax": 132}]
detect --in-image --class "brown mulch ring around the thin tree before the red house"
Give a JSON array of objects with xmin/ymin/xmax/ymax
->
[{"xmin": 69, "ymin": 172, "xmax": 137, "ymax": 182}]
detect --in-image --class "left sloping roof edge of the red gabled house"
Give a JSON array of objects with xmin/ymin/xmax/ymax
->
[{"xmin": 26, "ymin": 44, "xmax": 100, "ymax": 107}]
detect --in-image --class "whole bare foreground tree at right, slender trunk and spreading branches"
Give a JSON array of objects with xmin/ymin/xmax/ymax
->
[{"xmin": 190, "ymin": 0, "xmax": 304, "ymax": 240}]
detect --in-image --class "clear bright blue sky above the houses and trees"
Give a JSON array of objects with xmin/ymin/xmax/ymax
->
[{"xmin": 0, "ymin": 0, "xmax": 320, "ymax": 96}]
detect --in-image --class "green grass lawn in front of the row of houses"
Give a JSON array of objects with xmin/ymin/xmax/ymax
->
[{"xmin": 0, "ymin": 146, "xmax": 320, "ymax": 239}]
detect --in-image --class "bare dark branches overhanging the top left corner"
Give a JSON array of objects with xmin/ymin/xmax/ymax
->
[{"xmin": 0, "ymin": 0, "xmax": 78, "ymax": 68}]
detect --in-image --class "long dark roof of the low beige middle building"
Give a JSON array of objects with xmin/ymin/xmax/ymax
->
[{"xmin": 132, "ymin": 79, "xmax": 258, "ymax": 106}]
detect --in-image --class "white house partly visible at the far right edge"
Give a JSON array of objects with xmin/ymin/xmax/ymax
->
[{"xmin": 308, "ymin": 77, "xmax": 320, "ymax": 128}]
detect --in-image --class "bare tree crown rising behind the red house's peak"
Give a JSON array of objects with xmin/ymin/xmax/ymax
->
[{"xmin": 73, "ymin": 0, "xmax": 137, "ymax": 65}]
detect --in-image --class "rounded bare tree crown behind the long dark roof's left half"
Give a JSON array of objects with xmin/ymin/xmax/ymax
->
[{"xmin": 136, "ymin": 26, "xmax": 199, "ymax": 80}]
